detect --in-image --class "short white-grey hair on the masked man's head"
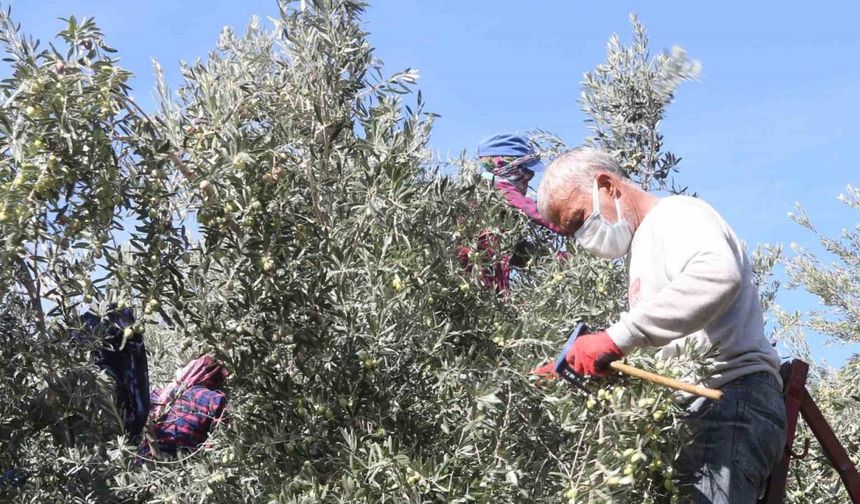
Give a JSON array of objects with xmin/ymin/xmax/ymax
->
[{"xmin": 538, "ymin": 147, "xmax": 628, "ymax": 218}]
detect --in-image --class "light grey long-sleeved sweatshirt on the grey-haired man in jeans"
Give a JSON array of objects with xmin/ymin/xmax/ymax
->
[{"xmin": 607, "ymin": 196, "xmax": 781, "ymax": 387}]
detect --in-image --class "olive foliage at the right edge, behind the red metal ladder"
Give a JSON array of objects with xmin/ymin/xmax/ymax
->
[{"xmin": 777, "ymin": 186, "xmax": 860, "ymax": 503}]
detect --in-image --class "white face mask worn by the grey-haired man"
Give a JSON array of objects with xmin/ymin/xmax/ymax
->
[{"xmin": 573, "ymin": 179, "xmax": 633, "ymax": 259}]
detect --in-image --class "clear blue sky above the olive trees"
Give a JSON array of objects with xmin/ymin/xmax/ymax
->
[{"xmin": 11, "ymin": 0, "xmax": 860, "ymax": 364}]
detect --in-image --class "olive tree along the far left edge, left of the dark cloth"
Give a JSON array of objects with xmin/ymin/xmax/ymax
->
[{"xmin": 0, "ymin": 10, "xmax": 170, "ymax": 499}]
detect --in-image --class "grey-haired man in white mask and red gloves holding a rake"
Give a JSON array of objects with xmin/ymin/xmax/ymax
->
[{"xmin": 538, "ymin": 147, "xmax": 786, "ymax": 504}]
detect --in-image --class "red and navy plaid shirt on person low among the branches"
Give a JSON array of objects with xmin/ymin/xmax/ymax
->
[{"xmin": 137, "ymin": 385, "xmax": 227, "ymax": 458}]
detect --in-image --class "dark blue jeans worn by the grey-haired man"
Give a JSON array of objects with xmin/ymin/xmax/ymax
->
[{"xmin": 678, "ymin": 372, "xmax": 786, "ymax": 504}]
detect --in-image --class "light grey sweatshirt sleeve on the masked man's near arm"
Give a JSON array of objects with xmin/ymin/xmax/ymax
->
[{"xmin": 607, "ymin": 205, "xmax": 743, "ymax": 353}]
